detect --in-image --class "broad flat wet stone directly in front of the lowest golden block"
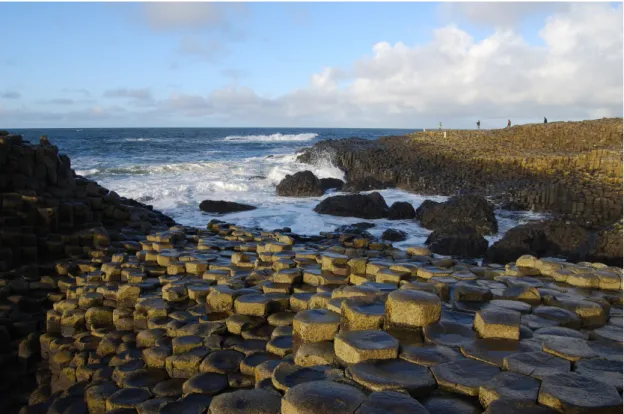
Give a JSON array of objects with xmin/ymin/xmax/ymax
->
[{"xmin": 347, "ymin": 359, "xmax": 436, "ymax": 398}]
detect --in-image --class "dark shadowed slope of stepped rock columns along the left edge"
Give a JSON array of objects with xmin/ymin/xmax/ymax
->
[{"xmin": 0, "ymin": 131, "xmax": 174, "ymax": 413}]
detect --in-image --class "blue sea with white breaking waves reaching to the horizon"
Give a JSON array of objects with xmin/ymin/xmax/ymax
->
[{"xmin": 11, "ymin": 128, "xmax": 542, "ymax": 247}]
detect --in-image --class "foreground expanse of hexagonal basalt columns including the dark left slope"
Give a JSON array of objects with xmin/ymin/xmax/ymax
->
[{"xmin": 0, "ymin": 133, "xmax": 622, "ymax": 414}]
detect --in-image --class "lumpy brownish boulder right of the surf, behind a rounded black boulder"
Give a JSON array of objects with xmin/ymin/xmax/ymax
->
[{"xmin": 416, "ymin": 194, "xmax": 498, "ymax": 234}]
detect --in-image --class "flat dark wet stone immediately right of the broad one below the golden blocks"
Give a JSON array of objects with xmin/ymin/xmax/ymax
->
[{"xmin": 431, "ymin": 359, "xmax": 500, "ymax": 397}]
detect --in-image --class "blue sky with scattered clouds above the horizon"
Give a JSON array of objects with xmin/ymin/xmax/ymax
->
[{"xmin": 0, "ymin": 2, "xmax": 623, "ymax": 129}]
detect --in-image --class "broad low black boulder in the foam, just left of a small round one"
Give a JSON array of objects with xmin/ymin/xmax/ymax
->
[{"xmin": 314, "ymin": 192, "xmax": 388, "ymax": 219}]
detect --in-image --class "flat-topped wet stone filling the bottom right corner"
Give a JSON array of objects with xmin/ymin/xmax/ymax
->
[{"xmin": 538, "ymin": 372, "xmax": 622, "ymax": 414}]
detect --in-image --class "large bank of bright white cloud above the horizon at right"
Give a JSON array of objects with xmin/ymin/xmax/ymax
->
[{"xmin": 0, "ymin": 3, "xmax": 623, "ymax": 128}]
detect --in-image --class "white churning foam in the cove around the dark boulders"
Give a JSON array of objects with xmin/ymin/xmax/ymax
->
[{"xmin": 84, "ymin": 149, "xmax": 543, "ymax": 252}]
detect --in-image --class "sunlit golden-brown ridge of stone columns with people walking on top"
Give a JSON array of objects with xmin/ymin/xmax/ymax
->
[{"xmin": 298, "ymin": 118, "xmax": 623, "ymax": 228}]
